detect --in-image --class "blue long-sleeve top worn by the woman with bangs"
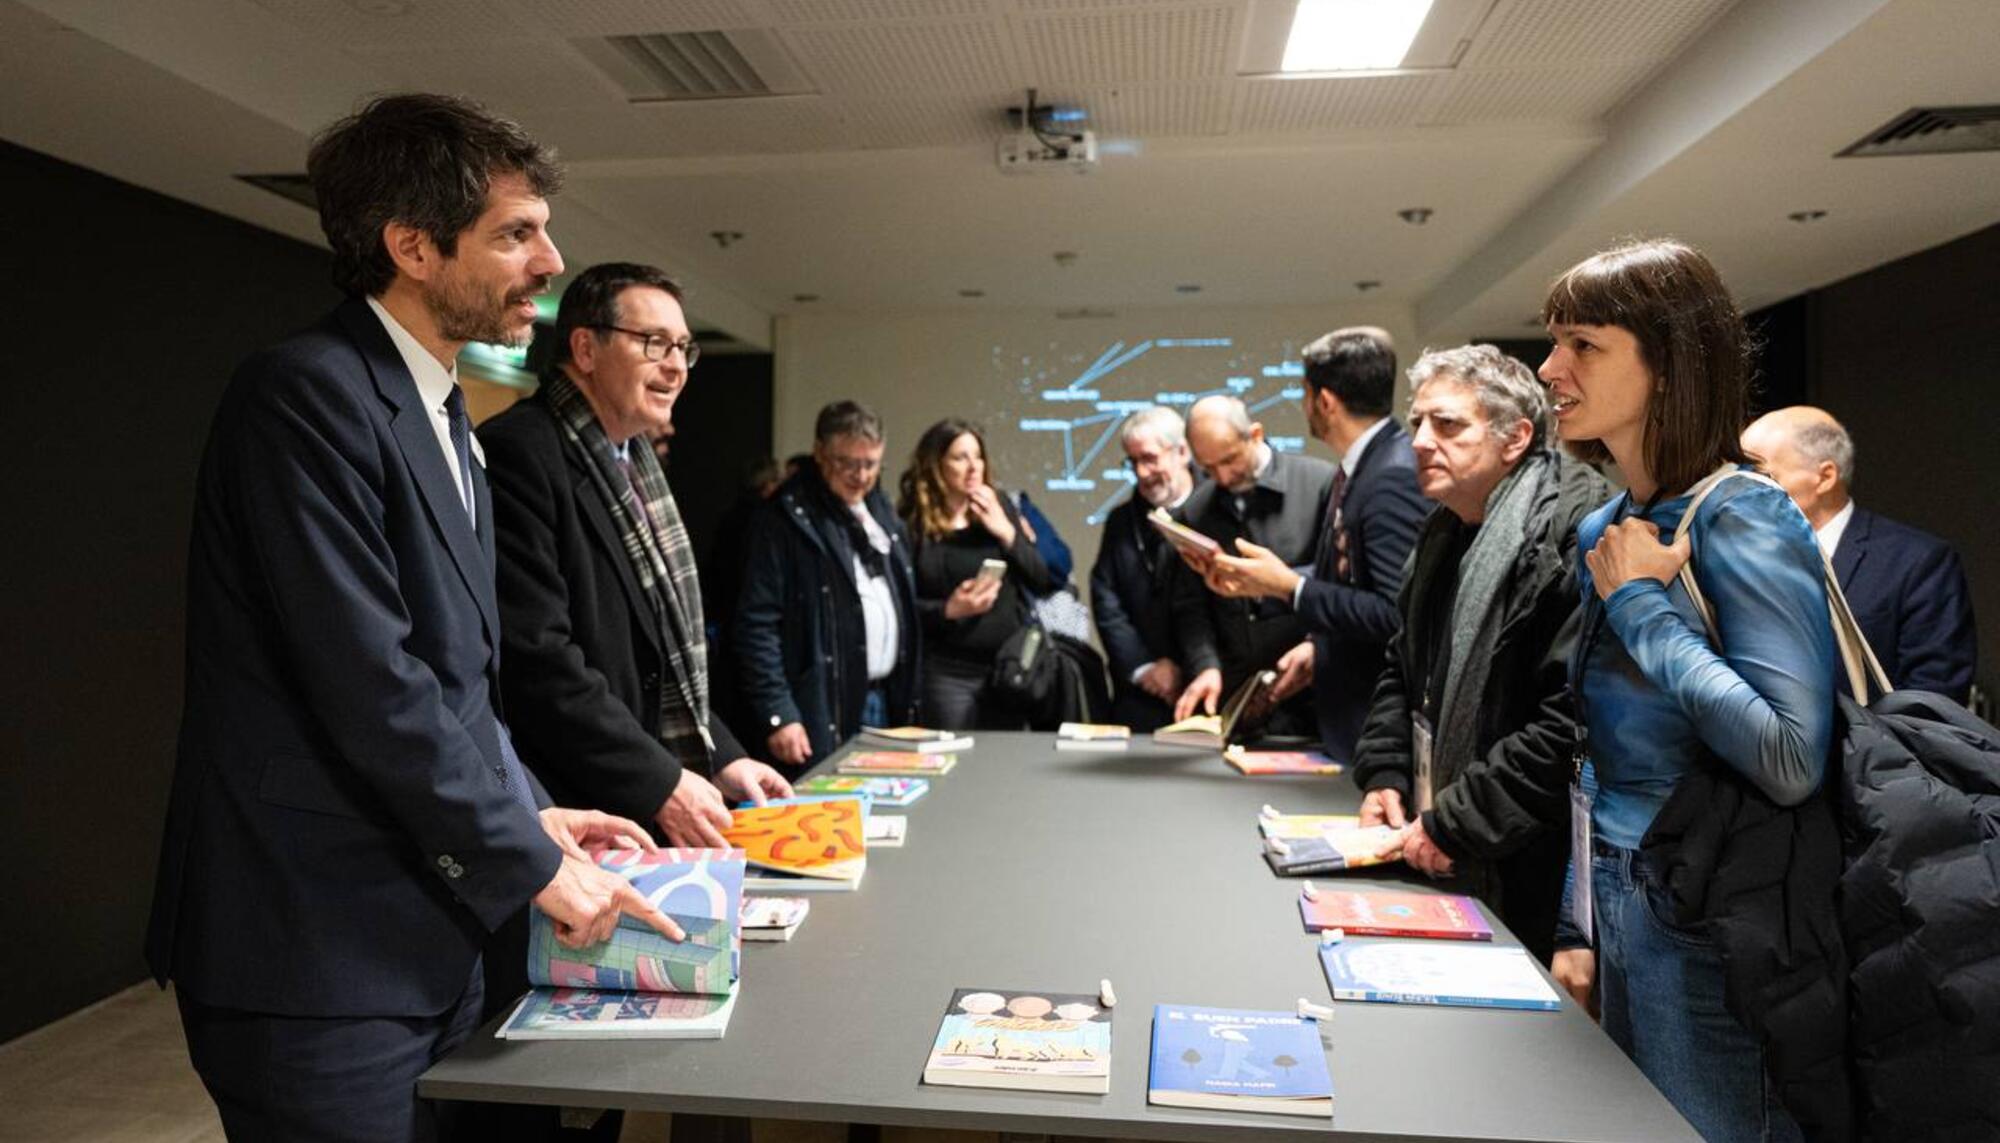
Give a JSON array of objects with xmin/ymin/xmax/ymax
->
[{"xmin": 1570, "ymin": 469, "xmax": 1838, "ymax": 849}]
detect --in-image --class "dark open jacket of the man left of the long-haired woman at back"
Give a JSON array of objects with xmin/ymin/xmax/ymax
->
[{"xmin": 730, "ymin": 468, "xmax": 922, "ymax": 759}]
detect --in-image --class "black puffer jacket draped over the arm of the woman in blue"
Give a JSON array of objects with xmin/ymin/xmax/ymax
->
[{"xmin": 1642, "ymin": 691, "xmax": 2000, "ymax": 1143}]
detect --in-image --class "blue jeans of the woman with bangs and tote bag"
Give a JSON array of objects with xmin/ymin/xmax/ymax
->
[{"xmin": 1590, "ymin": 839, "xmax": 1804, "ymax": 1143}]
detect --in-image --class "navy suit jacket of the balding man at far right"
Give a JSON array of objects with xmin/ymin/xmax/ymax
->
[{"xmin": 1834, "ymin": 508, "xmax": 1978, "ymax": 703}]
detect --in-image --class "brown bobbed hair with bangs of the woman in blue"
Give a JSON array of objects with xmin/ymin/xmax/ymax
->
[{"xmin": 1542, "ymin": 238, "xmax": 1754, "ymax": 494}]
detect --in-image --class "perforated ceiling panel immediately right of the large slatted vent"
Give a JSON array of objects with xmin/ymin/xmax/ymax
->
[{"xmin": 780, "ymin": 20, "xmax": 1016, "ymax": 96}]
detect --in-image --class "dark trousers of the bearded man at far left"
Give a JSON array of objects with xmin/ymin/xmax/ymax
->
[{"xmin": 178, "ymin": 965, "xmax": 486, "ymax": 1143}]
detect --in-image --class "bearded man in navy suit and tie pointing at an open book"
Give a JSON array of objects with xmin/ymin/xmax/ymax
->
[{"xmin": 146, "ymin": 96, "xmax": 680, "ymax": 1141}]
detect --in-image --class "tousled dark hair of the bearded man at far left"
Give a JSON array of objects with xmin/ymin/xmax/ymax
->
[{"xmin": 306, "ymin": 94, "xmax": 562, "ymax": 296}]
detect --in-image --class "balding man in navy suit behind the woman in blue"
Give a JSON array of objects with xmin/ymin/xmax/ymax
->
[{"xmin": 1742, "ymin": 406, "xmax": 1978, "ymax": 703}]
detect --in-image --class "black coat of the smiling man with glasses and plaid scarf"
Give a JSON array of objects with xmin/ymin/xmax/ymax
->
[{"xmin": 480, "ymin": 396, "xmax": 744, "ymax": 823}]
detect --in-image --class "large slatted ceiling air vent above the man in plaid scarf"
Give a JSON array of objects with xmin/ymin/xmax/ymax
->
[{"xmin": 572, "ymin": 28, "xmax": 812, "ymax": 104}]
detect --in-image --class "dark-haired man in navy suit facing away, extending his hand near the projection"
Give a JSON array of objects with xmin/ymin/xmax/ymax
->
[{"xmin": 1208, "ymin": 326, "xmax": 1432, "ymax": 759}]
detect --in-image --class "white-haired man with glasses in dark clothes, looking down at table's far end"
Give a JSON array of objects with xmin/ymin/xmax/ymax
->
[{"xmin": 1090, "ymin": 406, "xmax": 1194, "ymax": 731}]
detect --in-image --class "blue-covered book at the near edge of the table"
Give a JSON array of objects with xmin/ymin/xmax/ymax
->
[{"xmin": 1146, "ymin": 1003, "xmax": 1334, "ymax": 1119}]
